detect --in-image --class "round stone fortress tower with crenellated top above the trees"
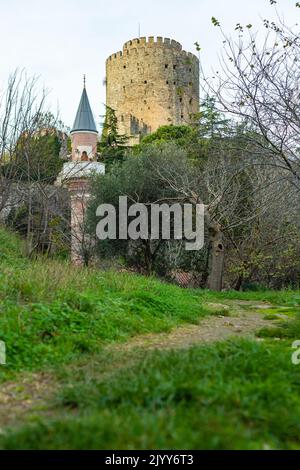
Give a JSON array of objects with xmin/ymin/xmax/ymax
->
[{"xmin": 106, "ymin": 37, "xmax": 199, "ymax": 145}]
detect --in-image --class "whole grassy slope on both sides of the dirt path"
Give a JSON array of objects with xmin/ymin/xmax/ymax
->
[{"xmin": 0, "ymin": 231, "xmax": 300, "ymax": 449}]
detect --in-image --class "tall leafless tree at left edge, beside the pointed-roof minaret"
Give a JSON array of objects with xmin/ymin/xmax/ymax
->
[{"xmin": 0, "ymin": 70, "xmax": 73, "ymax": 255}]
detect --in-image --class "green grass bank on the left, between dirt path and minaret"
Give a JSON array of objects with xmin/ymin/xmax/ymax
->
[{"xmin": 0, "ymin": 230, "xmax": 210, "ymax": 380}]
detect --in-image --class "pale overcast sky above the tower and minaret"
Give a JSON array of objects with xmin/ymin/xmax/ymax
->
[{"xmin": 0, "ymin": 0, "xmax": 299, "ymax": 126}]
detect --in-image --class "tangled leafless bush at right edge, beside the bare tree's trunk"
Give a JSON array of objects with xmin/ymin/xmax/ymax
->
[{"xmin": 225, "ymin": 172, "xmax": 300, "ymax": 290}]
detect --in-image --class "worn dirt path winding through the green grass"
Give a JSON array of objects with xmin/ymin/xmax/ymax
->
[{"xmin": 0, "ymin": 300, "xmax": 282, "ymax": 432}]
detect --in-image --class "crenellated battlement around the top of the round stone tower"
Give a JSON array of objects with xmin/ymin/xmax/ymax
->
[{"xmin": 106, "ymin": 36, "xmax": 198, "ymax": 62}]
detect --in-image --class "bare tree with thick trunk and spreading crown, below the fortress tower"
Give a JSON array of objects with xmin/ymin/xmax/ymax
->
[{"xmin": 148, "ymin": 143, "xmax": 286, "ymax": 290}]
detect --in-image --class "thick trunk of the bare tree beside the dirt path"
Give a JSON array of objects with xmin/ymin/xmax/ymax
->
[{"xmin": 207, "ymin": 223, "xmax": 224, "ymax": 291}]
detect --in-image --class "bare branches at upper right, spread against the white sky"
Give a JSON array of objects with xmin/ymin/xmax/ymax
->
[{"xmin": 204, "ymin": 2, "xmax": 300, "ymax": 190}]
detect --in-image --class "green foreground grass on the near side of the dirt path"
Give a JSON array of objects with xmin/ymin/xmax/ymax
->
[{"xmin": 0, "ymin": 340, "xmax": 300, "ymax": 449}]
